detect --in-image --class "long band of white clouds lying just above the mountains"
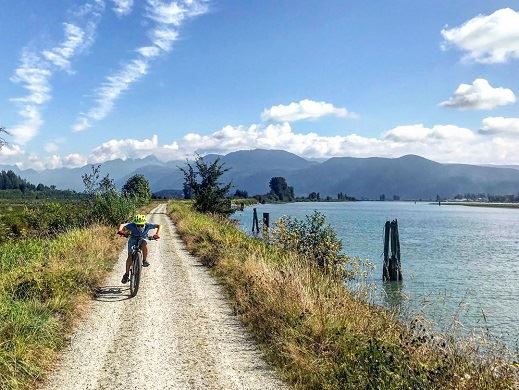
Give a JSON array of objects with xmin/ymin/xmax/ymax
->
[{"xmin": 17, "ymin": 118, "xmax": 519, "ymax": 169}]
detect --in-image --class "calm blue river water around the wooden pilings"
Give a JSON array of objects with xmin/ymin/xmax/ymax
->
[{"xmin": 235, "ymin": 202, "xmax": 519, "ymax": 349}]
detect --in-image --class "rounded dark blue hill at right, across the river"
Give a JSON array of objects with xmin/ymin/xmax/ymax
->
[{"xmin": 287, "ymin": 155, "xmax": 519, "ymax": 199}]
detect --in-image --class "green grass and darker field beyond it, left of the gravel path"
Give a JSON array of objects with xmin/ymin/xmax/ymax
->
[{"xmin": 0, "ymin": 201, "xmax": 158, "ymax": 389}]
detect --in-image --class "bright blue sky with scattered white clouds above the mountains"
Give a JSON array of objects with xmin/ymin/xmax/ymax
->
[{"xmin": 0, "ymin": 0, "xmax": 519, "ymax": 169}]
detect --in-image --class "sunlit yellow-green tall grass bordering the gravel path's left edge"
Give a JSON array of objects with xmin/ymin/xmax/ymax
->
[{"xmin": 0, "ymin": 226, "xmax": 120, "ymax": 389}]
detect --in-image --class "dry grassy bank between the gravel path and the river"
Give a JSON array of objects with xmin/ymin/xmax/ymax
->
[{"xmin": 169, "ymin": 202, "xmax": 518, "ymax": 389}]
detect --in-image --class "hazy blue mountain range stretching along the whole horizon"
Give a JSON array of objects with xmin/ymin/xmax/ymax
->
[{"xmin": 0, "ymin": 149, "xmax": 519, "ymax": 199}]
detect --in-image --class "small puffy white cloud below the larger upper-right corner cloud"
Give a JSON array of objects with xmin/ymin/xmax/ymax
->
[{"xmin": 440, "ymin": 79, "xmax": 516, "ymax": 110}]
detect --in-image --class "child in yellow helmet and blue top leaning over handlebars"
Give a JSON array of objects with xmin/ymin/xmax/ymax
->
[{"xmin": 117, "ymin": 214, "xmax": 160, "ymax": 283}]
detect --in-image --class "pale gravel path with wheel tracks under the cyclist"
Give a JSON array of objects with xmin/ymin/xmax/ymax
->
[{"xmin": 43, "ymin": 205, "xmax": 284, "ymax": 390}]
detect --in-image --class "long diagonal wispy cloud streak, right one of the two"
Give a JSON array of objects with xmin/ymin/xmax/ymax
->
[{"xmin": 72, "ymin": 0, "xmax": 207, "ymax": 131}]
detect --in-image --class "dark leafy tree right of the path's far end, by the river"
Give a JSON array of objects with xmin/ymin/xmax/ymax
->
[{"xmin": 179, "ymin": 155, "xmax": 232, "ymax": 215}]
